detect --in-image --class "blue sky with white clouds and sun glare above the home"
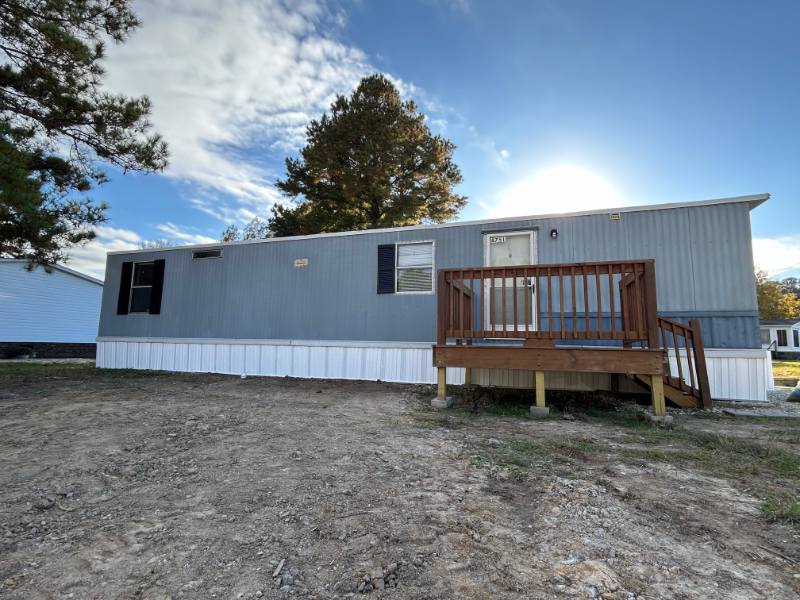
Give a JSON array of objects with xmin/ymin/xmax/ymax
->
[{"xmin": 65, "ymin": 0, "xmax": 800, "ymax": 277}]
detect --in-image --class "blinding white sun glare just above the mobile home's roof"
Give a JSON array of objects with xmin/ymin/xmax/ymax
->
[{"xmin": 494, "ymin": 166, "xmax": 623, "ymax": 217}]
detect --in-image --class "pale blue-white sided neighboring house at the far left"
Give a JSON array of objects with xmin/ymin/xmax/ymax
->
[{"xmin": 0, "ymin": 258, "xmax": 103, "ymax": 356}]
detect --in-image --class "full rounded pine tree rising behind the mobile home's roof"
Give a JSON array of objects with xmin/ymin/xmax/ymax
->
[{"xmin": 269, "ymin": 74, "xmax": 467, "ymax": 236}]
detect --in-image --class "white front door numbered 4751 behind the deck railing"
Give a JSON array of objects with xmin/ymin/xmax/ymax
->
[{"xmin": 483, "ymin": 231, "xmax": 537, "ymax": 331}]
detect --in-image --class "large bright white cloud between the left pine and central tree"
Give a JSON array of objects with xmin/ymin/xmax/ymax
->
[{"xmin": 102, "ymin": 0, "xmax": 370, "ymax": 216}]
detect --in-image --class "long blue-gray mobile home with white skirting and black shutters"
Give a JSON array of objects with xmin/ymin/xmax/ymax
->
[{"xmin": 97, "ymin": 194, "xmax": 772, "ymax": 403}]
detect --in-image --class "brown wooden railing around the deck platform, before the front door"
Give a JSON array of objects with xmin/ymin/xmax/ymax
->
[{"xmin": 437, "ymin": 260, "xmax": 659, "ymax": 348}]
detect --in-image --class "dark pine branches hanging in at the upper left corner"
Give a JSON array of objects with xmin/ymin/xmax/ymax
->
[{"xmin": 0, "ymin": 0, "xmax": 168, "ymax": 265}]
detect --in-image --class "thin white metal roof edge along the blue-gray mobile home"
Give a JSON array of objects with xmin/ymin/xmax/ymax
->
[{"xmin": 107, "ymin": 193, "xmax": 770, "ymax": 256}]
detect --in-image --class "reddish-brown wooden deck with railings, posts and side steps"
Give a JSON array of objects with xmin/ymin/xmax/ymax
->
[{"xmin": 434, "ymin": 260, "xmax": 711, "ymax": 415}]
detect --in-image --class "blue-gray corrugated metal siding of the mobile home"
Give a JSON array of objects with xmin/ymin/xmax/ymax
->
[{"xmin": 100, "ymin": 202, "xmax": 760, "ymax": 348}]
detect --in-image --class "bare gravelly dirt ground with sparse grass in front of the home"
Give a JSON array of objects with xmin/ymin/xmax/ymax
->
[{"xmin": 0, "ymin": 364, "xmax": 800, "ymax": 600}]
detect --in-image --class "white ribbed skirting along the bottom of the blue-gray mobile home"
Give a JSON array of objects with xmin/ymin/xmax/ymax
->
[{"xmin": 97, "ymin": 338, "xmax": 774, "ymax": 400}]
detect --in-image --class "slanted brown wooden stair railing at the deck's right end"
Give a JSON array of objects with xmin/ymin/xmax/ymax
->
[{"xmin": 658, "ymin": 317, "xmax": 711, "ymax": 409}]
